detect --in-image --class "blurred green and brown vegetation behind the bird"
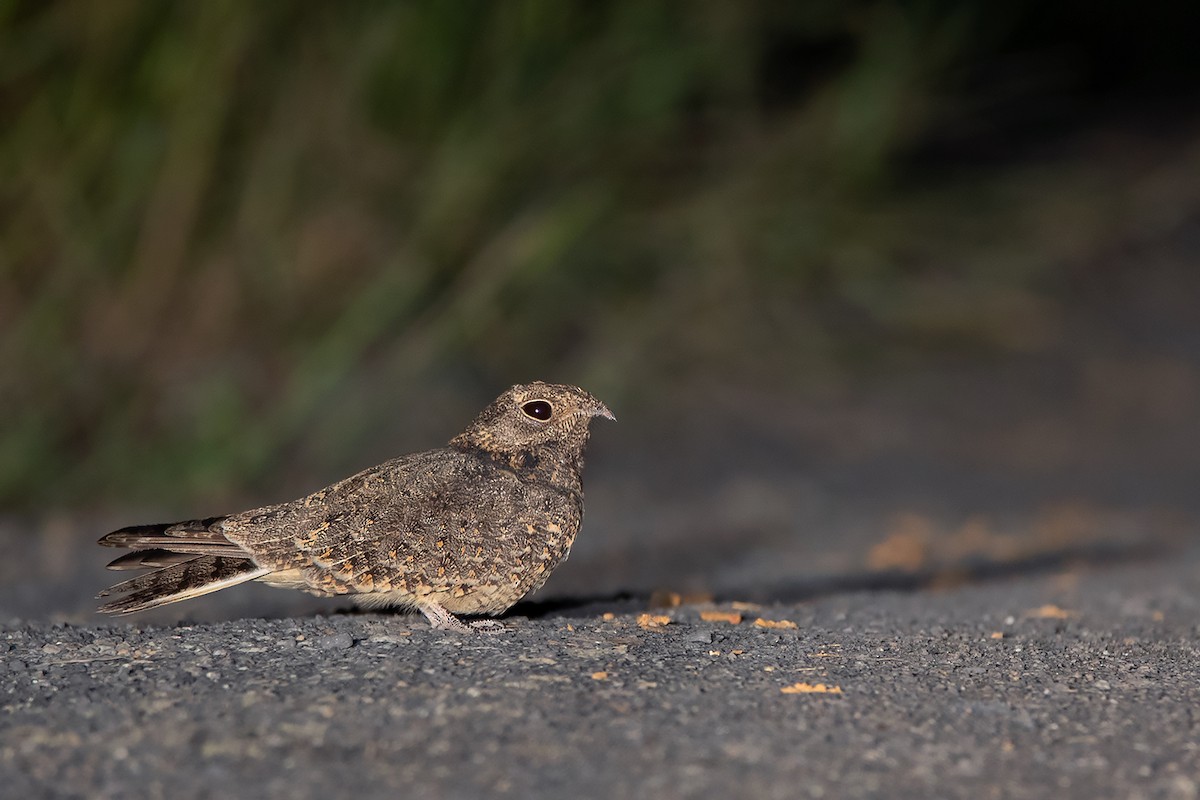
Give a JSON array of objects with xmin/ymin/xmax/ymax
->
[{"xmin": 0, "ymin": 0, "xmax": 1195, "ymax": 507}]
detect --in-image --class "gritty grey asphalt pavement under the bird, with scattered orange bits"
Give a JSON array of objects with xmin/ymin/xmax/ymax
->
[{"xmin": 0, "ymin": 537, "xmax": 1200, "ymax": 800}]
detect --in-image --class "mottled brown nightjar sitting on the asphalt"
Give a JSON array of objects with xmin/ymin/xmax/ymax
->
[{"xmin": 98, "ymin": 381, "xmax": 616, "ymax": 632}]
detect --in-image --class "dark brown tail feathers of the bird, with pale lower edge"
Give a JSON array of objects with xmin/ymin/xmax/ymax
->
[{"xmin": 100, "ymin": 517, "xmax": 270, "ymax": 614}]
